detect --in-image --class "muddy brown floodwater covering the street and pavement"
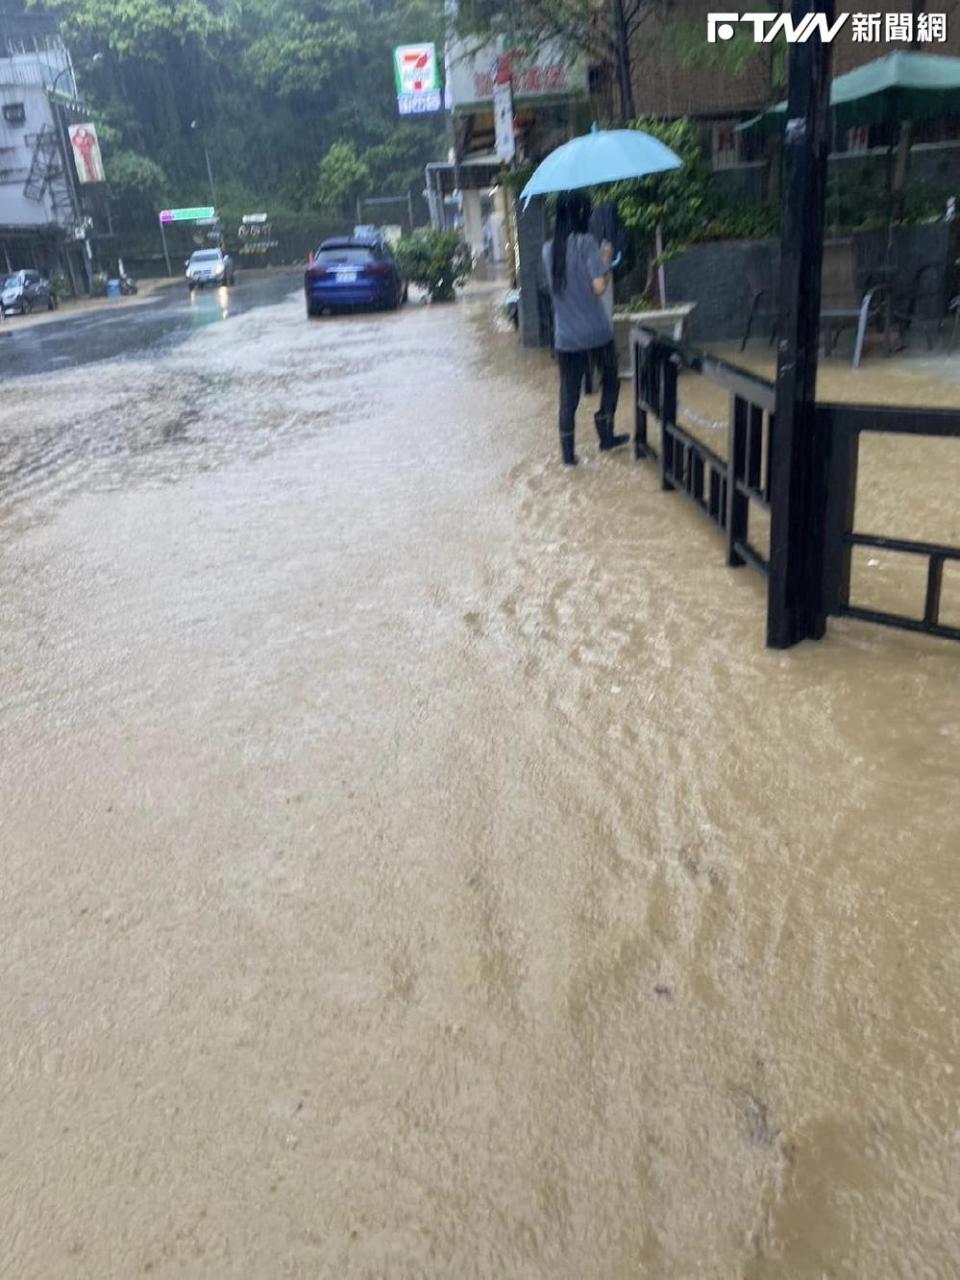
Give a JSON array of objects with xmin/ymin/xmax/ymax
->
[{"xmin": 0, "ymin": 277, "xmax": 960, "ymax": 1280}]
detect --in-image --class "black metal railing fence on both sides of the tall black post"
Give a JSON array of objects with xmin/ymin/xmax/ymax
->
[{"xmin": 631, "ymin": 325, "xmax": 960, "ymax": 640}]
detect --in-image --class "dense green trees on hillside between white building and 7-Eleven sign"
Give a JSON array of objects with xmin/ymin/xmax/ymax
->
[{"xmin": 29, "ymin": 0, "xmax": 444, "ymax": 221}]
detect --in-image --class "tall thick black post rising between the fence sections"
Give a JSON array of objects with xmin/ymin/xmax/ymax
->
[{"xmin": 767, "ymin": 0, "xmax": 833, "ymax": 649}]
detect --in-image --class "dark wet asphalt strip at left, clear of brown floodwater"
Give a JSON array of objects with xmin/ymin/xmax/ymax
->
[{"xmin": 0, "ymin": 269, "xmax": 300, "ymax": 378}]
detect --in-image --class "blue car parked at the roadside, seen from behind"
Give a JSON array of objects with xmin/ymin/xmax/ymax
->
[{"xmin": 303, "ymin": 237, "xmax": 407, "ymax": 316}]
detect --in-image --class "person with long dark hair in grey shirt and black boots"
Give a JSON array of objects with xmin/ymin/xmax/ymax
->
[{"xmin": 543, "ymin": 191, "xmax": 630, "ymax": 467}]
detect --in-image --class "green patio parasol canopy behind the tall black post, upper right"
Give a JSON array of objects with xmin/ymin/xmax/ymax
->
[{"xmin": 737, "ymin": 51, "xmax": 960, "ymax": 134}]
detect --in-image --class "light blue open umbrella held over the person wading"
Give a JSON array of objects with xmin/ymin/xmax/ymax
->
[{"xmin": 520, "ymin": 124, "xmax": 684, "ymax": 209}]
